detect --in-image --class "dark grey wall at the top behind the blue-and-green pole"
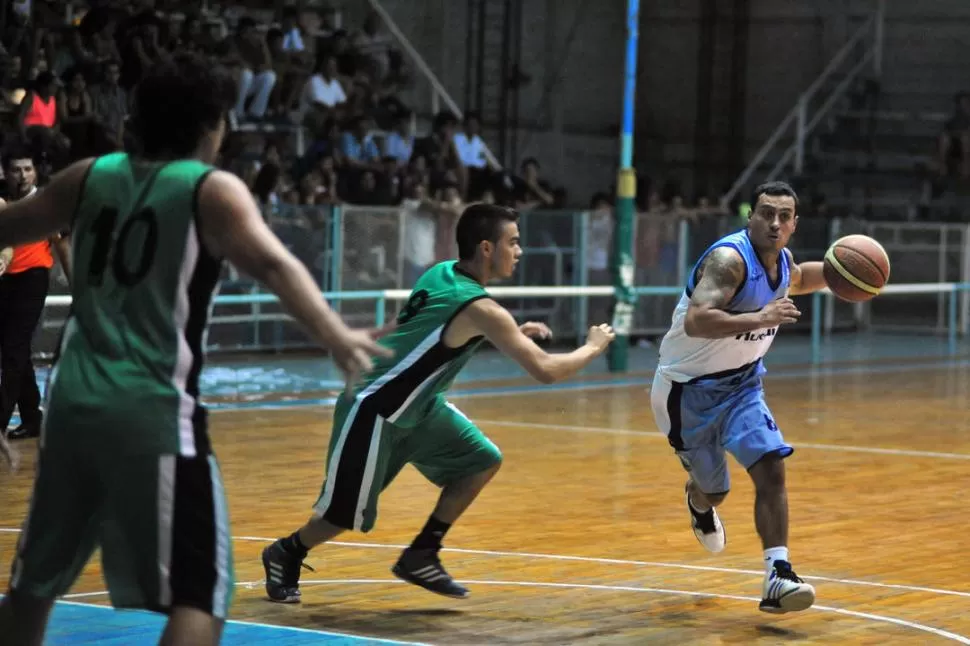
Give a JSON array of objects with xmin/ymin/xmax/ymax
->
[{"xmin": 344, "ymin": 0, "xmax": 970, "ymax": 202}]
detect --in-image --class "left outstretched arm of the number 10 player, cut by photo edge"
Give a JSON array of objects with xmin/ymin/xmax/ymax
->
[{"xmin": 0, "ymin": 159, "xmax": 94, "ymax": 247}]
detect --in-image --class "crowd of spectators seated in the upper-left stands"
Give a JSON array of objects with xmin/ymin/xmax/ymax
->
[{"xmin": 0, "ymin": 0, "xmax": 565, "ymax": 214}]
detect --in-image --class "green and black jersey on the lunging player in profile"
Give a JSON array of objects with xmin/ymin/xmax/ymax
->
[{"xmin": 356, "ymin": 260, "xmax": 488, "ymax": 427}]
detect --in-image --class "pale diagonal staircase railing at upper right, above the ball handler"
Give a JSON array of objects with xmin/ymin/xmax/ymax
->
[{"xmin": 721, "ymin": 0, "xmax": 886, "ymax": 206}]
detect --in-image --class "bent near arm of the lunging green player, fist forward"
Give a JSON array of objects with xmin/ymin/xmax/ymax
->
[{"xmin": 459, "ymin": 299, "xmax": 614, "ymax": 384}]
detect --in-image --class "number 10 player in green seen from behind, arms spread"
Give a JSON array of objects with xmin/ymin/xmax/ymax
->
[{"xmin": 0, "ymin": 55, "xmax": 391, "ymax": 646}]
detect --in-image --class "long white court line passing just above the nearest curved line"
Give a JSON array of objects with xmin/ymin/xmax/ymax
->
[{"xmin": 0, "ymin": 527, "xmax": 970, "ymax": 598}]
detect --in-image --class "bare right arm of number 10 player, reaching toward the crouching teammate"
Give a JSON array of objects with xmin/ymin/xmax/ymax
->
[{"xmin": 198, "ymin": 171, "xmax": 391, "ymax": 377}]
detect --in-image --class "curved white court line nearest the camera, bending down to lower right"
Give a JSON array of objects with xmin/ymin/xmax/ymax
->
[{"xmin": 66, "ymin": 579, "xmax": 970, "ymax": 644}]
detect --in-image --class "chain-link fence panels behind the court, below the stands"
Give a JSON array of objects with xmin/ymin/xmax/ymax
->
[{"xmin": 35, "ymin": 208, "xmax": 970, "ymax": 355}]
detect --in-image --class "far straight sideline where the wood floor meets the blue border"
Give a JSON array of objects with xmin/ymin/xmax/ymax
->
[{"xmin": 203, "ymin": 359, "xmax": 970, "ymax": 413}]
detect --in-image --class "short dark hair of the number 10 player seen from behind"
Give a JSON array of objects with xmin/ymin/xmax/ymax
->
[{"xmin": 132, "ymin": 53, "xmax": 235, "ymax": 157}]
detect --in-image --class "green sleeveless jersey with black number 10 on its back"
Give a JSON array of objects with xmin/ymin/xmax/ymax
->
[{"xmin": 47, "ymin": 153, "xmax": 222, "ymax": 456}]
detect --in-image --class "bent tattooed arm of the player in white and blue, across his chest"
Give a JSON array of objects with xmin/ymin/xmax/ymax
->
[{"xmin": 684, "ymin": 247, "xmax": 799, "ymax": 339}]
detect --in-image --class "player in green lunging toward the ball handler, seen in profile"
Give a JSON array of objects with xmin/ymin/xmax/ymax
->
[{"xmin": 263, "ymin": 204, "xmax": 613, "ymax": 603}]
